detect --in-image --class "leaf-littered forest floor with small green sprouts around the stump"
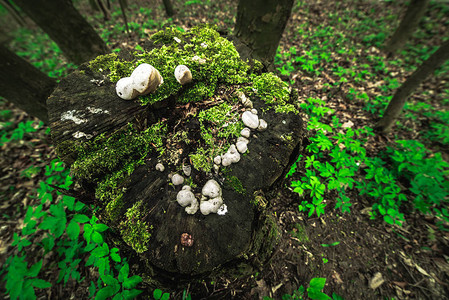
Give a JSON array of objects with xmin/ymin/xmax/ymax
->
[{"xmin": 0, "ymin": 1, "xmax": 449, "ymax": 299}]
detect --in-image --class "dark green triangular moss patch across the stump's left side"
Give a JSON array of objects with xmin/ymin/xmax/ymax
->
[{"xmin": 69, "ymin": 123, "xmax": 167, "ymax": 221}]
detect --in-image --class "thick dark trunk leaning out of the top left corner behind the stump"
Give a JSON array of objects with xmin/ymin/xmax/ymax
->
[{"xmin": 14, "ymin": 0, "xmax": 109, "ymax": 65}]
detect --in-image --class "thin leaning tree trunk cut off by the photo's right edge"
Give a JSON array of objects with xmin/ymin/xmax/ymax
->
[{"xmin": 376, "ymin": 40, "xmax": 449, "ymax": 133}]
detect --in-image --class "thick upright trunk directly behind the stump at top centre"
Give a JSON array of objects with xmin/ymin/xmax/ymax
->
[{"xmin": 234, "ymin": 0, "xmax": 293, "ymax": 70}]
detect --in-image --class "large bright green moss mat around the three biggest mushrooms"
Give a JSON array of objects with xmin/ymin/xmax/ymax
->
[{"xmin": 89, "ymin": 25, "xmax": 250, "ymax": 105}]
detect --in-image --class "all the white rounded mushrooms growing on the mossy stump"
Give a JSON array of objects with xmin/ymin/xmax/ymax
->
[{"xmin": 116, "ymin": 63, "xmax": 267, "ymax": 215}]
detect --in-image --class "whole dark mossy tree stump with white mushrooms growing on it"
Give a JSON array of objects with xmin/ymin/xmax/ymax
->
[{"xmin": 48, "ymin": 27, "xmax": 303, "ymax": 275}]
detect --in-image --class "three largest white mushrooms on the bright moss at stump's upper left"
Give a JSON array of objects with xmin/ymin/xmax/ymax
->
[{"xmin": 115, "ymin": 63, "xmax": 192, "ymax": 100}]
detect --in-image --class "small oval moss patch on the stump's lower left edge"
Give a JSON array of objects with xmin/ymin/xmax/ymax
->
[{"xmin": 120, "ymin": 201, "xmax": 153, "ymax": 253}]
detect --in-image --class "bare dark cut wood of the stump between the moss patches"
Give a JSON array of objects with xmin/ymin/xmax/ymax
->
[{"xmin": 48, "ymin": 54, "xmax": 303, "ymax": 275}]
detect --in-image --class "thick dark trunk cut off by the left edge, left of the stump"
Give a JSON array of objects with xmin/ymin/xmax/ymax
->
[{"xmin": 0, "ymin": 44, "xmax": 56, "ymax": 123}]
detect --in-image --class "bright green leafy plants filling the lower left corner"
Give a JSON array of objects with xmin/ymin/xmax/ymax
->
[{"xmin": 1, "ymin": 160, "xmax": 142, "ymax": 299}]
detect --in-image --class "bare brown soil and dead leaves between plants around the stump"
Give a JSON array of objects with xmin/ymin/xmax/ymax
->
[{"xmin": 0, "ymin": 1, "xmax": 449, "ymax": 299}]
